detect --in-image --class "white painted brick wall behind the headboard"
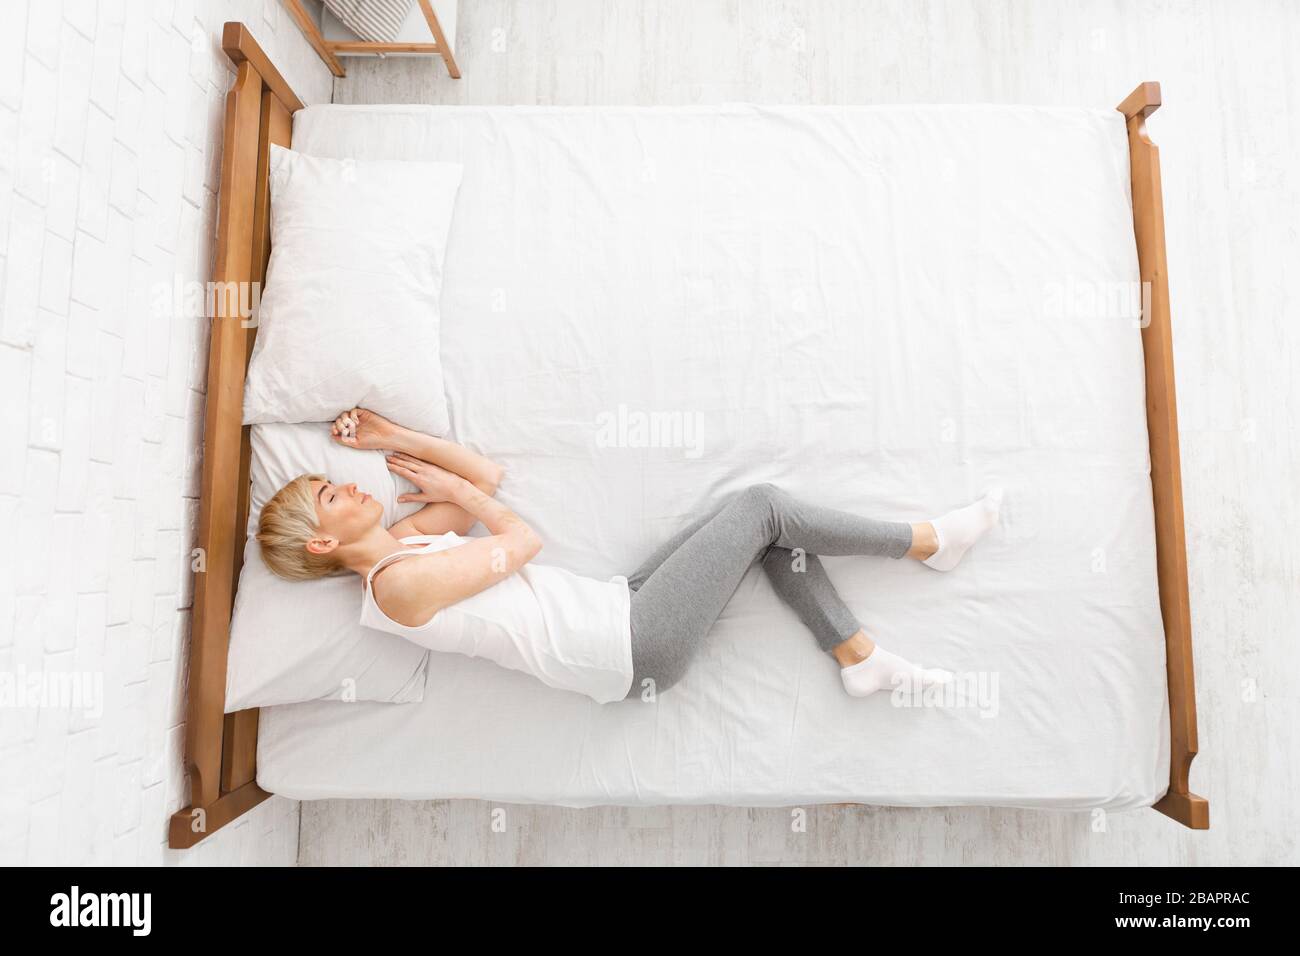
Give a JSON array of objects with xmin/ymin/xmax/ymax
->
[{"xmin": 0, "ymin": 0, "xmax": 330, "ymax": 864}]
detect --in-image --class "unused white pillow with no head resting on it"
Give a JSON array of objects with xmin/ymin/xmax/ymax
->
[{"xmin": 244, "ymin": 146, "xmax": 462, "ymax": 434}]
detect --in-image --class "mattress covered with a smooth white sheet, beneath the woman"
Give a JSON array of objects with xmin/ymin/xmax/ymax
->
[{"xmin": 257, "ymin": 105, "xmax": 1169, "ymax": 810}]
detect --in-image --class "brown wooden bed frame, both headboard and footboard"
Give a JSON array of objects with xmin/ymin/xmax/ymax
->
[{"xmin": 169, "ymin": 23, "xmax": 1209, "ymax": 848}]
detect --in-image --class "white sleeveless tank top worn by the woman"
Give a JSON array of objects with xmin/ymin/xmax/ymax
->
[{"xmin": 361, "ymin": 531, "xmax": 632, "ymax": 704}]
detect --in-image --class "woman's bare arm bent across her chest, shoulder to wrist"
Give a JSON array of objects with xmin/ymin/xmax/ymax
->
[{"xmin": 374, "ymin": 475, "xmax": 542, "ymax": 627}]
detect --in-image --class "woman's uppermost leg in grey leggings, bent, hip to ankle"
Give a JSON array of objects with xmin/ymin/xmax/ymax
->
[{"xmin": 629, "ymin": 485, "xmax": 913, "ymax": 696}]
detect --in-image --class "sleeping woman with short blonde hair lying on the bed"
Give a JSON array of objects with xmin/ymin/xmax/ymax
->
[{"xmin": 257, "ymin": 408, "xmax": 1001, "ymax": 702}]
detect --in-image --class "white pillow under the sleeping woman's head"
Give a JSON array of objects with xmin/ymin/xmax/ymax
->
[{"xmin": 226, "ymin": 424, "xmax": 429, "ymax": 714}]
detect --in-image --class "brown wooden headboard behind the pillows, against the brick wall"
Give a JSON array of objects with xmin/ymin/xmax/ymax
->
[{"xmin": 168, "ymin": 23, "xmax": 303, "ymax": 848}]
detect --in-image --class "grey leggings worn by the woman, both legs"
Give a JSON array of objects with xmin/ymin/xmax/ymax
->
[{"xmin": 628, "ymin": 485, "xmax": 911, "ymax": 697}]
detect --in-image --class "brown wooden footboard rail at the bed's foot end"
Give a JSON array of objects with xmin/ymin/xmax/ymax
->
[{"xmin": 1118, "ymin": 83, "xmax": 1210, "ymax": 830}]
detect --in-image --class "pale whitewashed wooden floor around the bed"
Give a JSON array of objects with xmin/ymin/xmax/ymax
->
[{"xmin": 300, "ymin": 0, "xmax": 1300, "ymax": 864}]
